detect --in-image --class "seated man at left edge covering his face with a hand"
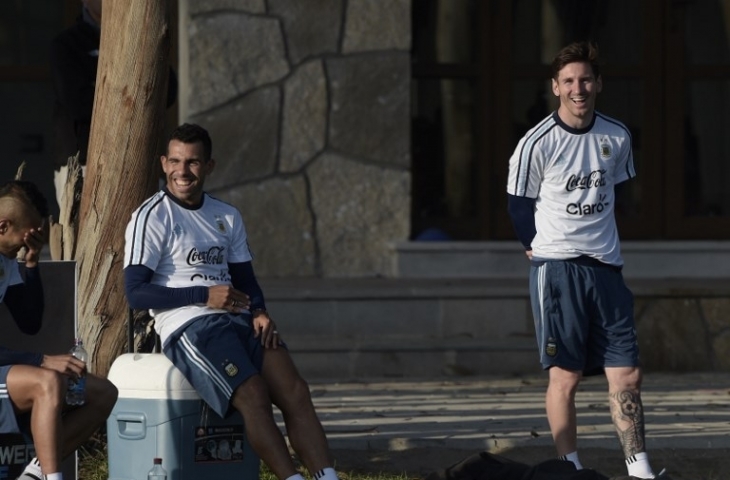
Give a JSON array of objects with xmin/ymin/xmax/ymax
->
[{"xmin": 0, "ymin": 181, "xmax": 117, "ymax": 480}]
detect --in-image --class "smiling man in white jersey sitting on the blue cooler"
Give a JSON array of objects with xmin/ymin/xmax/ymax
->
[{"xmin": 124, "ymin": 124, "xmax": 337, "ymax": 480}]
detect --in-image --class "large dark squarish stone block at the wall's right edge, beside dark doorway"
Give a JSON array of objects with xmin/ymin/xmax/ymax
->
[{"xmin": 327, "ymin": 52, "xmax": 411, "ymax": 168}]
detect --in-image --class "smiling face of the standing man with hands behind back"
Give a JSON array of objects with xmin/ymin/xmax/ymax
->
[{"xmin": 552, "ymin": 62, "xmax": 603, "ymax": 128}]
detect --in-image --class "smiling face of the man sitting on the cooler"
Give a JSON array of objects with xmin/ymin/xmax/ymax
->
[{"xmin": 160, "ymin": 140, "xmax": 215, "ymax": 206}]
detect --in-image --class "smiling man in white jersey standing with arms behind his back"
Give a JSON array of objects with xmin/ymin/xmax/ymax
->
[{"xmin": 507, "ymin": 42, "xmax": 668, "ymax": 479}]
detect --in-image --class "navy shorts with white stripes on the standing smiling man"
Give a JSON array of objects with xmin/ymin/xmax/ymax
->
[{"xmin": 530, "ymin": 257, "xmax": 639, "ymax": 375}]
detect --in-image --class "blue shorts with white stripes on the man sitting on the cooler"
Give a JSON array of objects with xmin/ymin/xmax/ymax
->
[{"xmin": 164, "ymin": 313, "xmax": 264, "ymax": 417}]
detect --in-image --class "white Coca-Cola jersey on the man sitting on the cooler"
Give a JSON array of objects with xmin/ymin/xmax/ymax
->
[{"xmin": 124, "ymin": 191, "xmax": 252, "ymax": 344}]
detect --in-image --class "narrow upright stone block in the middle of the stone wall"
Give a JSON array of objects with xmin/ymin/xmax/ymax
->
[{"xmin": 279, "ymin": 60, "xmax": 327, "ymax": 172}]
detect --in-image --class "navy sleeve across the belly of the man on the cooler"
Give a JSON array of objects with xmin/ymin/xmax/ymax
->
[{"xmin": 124, "ymin": 265, "xmax": 208, "ymax": 309}]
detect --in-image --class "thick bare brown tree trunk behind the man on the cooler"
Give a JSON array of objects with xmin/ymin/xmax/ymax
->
[{"xmin": 76, "ymin": 0, "xmax": 170, "ymax": 375}]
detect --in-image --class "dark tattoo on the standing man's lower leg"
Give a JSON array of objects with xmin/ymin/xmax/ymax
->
[{"xmin": 608, "ymin": 390, "xmax": 645, "ymax": 458}]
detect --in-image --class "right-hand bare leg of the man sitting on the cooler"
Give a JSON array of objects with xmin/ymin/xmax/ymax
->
[{"xmin": 261, "ymin": 348, "xmax": 333, "ymax": 474}]
